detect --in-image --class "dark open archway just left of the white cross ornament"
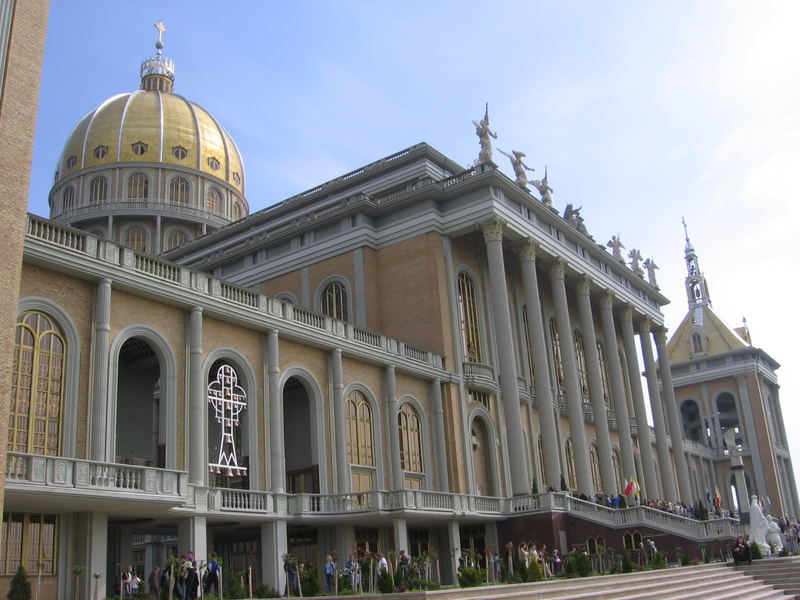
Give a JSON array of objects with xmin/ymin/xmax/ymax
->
[{"xmin": 114, "ymin": 337, "xmax": 166, "ymax": 468}]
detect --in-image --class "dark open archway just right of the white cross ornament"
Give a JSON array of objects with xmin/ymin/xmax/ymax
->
[{"xmin": 283, "ymin": 377, "xmax": 319, "ymax": 494}]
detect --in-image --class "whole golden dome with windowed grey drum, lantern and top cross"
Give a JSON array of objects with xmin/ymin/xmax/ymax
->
[{"xmin": 50, "ymin": 23, "xmax": 249, "ymax": 254}]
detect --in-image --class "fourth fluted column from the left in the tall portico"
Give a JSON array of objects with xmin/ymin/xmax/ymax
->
[{"xmin": 578, "ymin": 278, "xmax": 618, "ymax": 496}]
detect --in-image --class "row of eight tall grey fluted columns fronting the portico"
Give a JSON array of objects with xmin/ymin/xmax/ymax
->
[{"xmin": 481, "ymin": 219, "xmax": 693, "ymax": 504}]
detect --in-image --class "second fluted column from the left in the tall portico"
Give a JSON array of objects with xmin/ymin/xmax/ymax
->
[{"xmin": 518, "ymin": 240, "xmax": 561, "ymax": 491}]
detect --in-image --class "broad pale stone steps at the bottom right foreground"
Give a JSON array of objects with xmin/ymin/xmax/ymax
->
[{"xmin": 381, "ymin": 560, "xmax": 800, "ymax": 600}]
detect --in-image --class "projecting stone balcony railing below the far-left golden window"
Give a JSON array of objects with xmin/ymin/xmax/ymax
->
[{"xmin": 6, "ymin": 452, "xmax": 187, "ymax": 502}]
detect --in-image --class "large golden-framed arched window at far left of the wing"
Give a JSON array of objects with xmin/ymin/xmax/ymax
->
[{"xmin": 8, "ymin": 311, "xmax": 67, "ymax": 456}]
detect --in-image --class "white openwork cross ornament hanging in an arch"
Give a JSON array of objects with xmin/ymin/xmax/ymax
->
[{"xmin": 208, "ymin": 365, "xmax": 247, "ymax": 477}]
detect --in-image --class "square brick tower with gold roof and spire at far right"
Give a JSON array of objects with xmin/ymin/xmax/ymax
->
[{"xmin": 667, "ymin": 220, "xmax": 800, "ymax": 515}]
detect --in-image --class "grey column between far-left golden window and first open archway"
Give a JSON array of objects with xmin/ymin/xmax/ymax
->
[{"xmin": 89, "ymin": 278, "xmax": 113, "ymax": 462}]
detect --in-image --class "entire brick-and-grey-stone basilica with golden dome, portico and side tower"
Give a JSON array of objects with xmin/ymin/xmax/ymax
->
[{"xmin": 0, "ymin": 21, "xmax": 800, "ymax": 599}]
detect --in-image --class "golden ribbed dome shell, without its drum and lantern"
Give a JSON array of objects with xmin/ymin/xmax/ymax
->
[{"xmin": 56, "ymin": 90, "xmax": 244, "ymax": 195}]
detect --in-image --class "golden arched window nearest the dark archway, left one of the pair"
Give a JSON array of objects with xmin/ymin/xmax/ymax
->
[{"xmin": 345, "ymin": 391, "xmax": 375, "ymax": 492}]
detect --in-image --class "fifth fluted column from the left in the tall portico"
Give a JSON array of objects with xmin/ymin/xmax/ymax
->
[{"xmin": 600, "ymin": 292, "xmax": 636, "ymax": 480}]
